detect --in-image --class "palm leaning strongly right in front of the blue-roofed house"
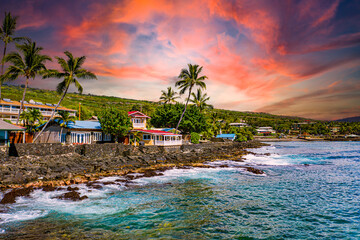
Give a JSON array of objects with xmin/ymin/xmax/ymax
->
[{"xmin": 33, "ymin": 51, "xmax": 97, "ymax": 142}]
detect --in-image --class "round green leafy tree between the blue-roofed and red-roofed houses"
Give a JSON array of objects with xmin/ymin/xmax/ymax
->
[{"xmin": 98, "ymin": 107, "xmax": 131, "ymax": 141}]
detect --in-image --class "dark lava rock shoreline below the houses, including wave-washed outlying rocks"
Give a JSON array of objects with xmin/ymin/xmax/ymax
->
[{"xmin": 0, "ymin": 141, "xmax": 265, "ymax": 204}]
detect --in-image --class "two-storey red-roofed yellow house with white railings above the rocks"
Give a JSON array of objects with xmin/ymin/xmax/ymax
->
[{"xmin": 125, "ymin": 111, "xmax": 182, "ymax": 146}]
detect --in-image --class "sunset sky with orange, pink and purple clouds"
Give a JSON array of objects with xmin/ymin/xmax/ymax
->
[{"xmin": 0, "ymin": 0, "xmax": 360, "ymax": 120}]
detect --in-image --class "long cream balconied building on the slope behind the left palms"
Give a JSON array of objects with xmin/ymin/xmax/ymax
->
[{"xmin": 0, "ymin": 98, "xmax": 76, "ymax": 123}]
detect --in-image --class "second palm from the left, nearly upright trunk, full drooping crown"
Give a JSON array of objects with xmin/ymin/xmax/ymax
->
[{"xmin": 2, "ymin": 39, "xmax": 51, "ymax": 124}]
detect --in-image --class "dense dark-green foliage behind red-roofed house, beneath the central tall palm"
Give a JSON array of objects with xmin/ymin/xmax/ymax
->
[{"xmin": 151, "ymin": 103, "xmax": 208, "ymax": 133}]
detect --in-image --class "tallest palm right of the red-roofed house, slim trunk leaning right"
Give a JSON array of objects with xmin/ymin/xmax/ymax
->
[{"xmin": 175, "ymin": 64, "xmax": 208, "ymax": 130}]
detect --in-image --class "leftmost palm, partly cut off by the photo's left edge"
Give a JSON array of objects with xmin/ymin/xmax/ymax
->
[{"xmin": 0, "ymin": 12, "xmax": 26, "ymax": 99}]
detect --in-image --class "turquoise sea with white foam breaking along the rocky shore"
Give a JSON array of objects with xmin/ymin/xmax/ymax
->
[{"xmin": 0, "ymin": 142, "xmax": 360, "ymax": 239}]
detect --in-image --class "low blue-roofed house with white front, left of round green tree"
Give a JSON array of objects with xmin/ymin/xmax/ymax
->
[{"xmin": 38, "ymin": 121, "xmax": 111, "ymax": 144}]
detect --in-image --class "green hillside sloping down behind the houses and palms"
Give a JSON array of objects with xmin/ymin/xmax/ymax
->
[{"xmin": 2, "ymin": 85, "xmax": 305, "ymax": 125}]
